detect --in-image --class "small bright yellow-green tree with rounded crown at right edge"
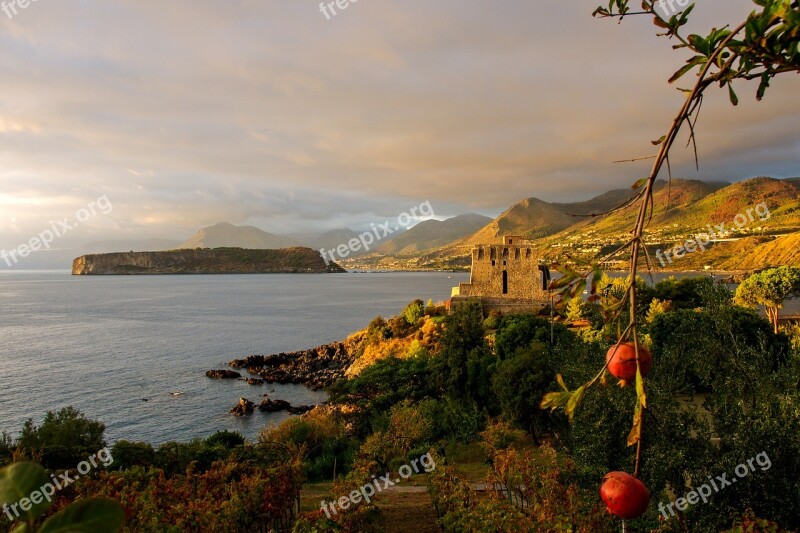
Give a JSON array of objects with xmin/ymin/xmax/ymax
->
[{"xmin": 736, "ymin": 266, "xmax": 800, "ymax": 333}]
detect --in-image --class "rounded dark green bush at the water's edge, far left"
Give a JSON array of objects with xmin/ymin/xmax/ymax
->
[{"xmin": 17, "ymin": 407, "xmax": 106, "ymax": 468}]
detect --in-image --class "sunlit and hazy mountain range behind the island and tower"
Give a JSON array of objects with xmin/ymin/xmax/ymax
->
[{"xmin": 64, "ymin": 177, "xmax": 800, "ymax": 270}]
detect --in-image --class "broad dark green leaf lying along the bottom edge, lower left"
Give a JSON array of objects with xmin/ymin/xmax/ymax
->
[{"xmin": 38, "ymin": 498, "xmax": 125, "ymax": 533}]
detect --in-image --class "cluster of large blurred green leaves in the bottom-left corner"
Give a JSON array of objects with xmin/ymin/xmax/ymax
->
[{"xmin": 0, "ymin": 462, "xmax": 125, "ymax": 533}]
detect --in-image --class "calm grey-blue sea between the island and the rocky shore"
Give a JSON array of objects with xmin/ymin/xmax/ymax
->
[{"xmin": 0, "ymin": 271, "xmax": 469, "ymax": 444}]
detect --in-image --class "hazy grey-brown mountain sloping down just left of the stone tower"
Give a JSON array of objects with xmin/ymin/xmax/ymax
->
[{"xmin": 377, "ymin": 213, "xmax": 492, "ymax": 255}]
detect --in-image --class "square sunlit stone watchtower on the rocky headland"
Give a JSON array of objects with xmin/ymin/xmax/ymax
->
[{"xmin": 451, "ymin": 236, "xmax": 550, "ymax": 315}]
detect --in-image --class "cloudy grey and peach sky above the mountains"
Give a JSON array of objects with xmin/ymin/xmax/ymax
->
[{"xmin": 0, "ymin": 0, "xmax": 800, "ymax": 249}]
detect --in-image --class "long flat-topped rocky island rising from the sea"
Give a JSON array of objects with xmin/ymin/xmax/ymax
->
[{"xmin": 72, "ymin": 248, "xmax": 345, "ymax": 276}]
